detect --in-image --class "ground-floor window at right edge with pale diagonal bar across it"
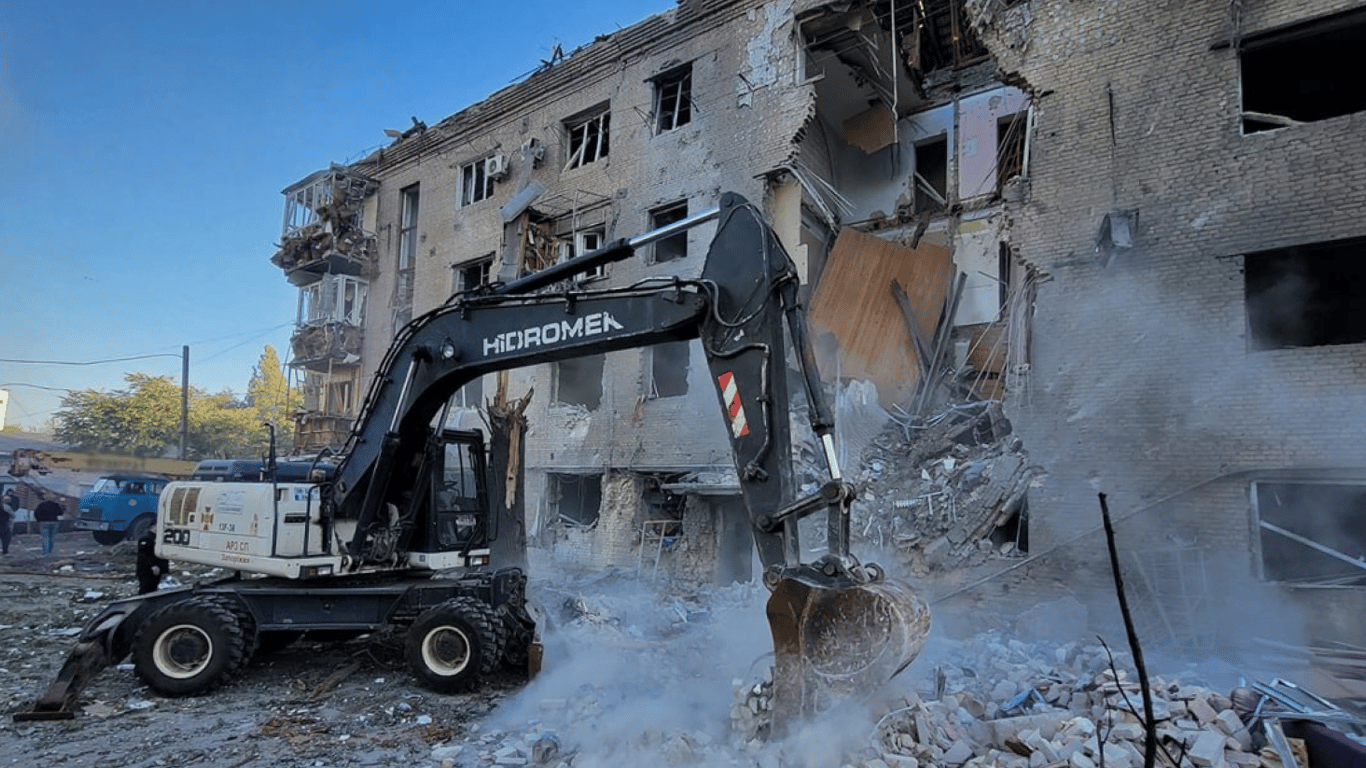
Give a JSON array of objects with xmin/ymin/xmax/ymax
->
[{"xmin": 1253, "ymin": 481, "xmax": 1366, "ymax": 586}]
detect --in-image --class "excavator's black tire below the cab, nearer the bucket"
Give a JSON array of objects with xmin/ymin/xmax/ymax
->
[{"xmin": 403, "ymin": 597, "xmax": 503, "ymax": 693}]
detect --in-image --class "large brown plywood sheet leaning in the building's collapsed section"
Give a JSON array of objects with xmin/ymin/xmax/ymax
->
[{"xmin": 810, "ymin": 228, "xmax": 953, "ymax": 407}]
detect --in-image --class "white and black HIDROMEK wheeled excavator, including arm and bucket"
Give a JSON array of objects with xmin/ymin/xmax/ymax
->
[{"xmin": 15, "ymin": 194, "xmax": 930, "ymax": 728}]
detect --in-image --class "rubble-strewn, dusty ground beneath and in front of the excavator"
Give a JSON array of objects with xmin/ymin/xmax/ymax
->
[{"xmin": 0, "ymin": 533, "xmax": 1344, "ymax": 768}]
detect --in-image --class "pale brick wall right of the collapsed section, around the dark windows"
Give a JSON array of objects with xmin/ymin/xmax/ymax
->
[{"xmin": 958, "ymin": 0, "xmax": 1366, "ymax": 645}]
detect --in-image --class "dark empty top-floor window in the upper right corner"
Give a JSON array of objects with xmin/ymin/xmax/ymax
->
[{"xmin": 1239, "ymin": 8, "xmax": 1366, "ymax": 133}]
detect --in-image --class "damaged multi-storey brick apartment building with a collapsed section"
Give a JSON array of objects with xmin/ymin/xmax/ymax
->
[{"xmin": 275, "ymin": 0, "xmax": 1366, "ymax": 650}]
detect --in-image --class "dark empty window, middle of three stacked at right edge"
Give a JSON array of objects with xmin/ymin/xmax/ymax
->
[{"xmin": 1243, "ymin": 238, "xmax": 1366, "ymax": 350}]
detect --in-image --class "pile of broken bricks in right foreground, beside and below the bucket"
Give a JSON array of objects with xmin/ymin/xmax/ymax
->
[{"xmin": 731, "ymin": 633, "xmax": 1333, "ymax": 768}]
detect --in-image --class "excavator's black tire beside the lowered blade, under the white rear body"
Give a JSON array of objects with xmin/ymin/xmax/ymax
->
[{"xmin": 133, "ymin": 596, "xmax": 246, "ymax": 696}]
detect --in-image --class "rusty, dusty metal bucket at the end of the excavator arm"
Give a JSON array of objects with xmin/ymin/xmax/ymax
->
[{"xmin": 768, "ymin": 575, "xmax": 930, "ymax": 737}]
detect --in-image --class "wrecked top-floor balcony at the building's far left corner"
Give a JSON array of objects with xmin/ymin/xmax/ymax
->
[{"xmin": 270, "ymin": 164, "xmax": 380, "ymax": 286}]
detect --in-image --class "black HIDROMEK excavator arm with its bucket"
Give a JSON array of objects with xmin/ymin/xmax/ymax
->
[{"xmin": 325, "ymin": 194, "xmax": 929, "ymax": 723}]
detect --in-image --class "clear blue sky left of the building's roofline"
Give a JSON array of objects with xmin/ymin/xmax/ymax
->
[{"xmin": 0, "ymin": 0, "xmax": 673, "ymax": 428}]
